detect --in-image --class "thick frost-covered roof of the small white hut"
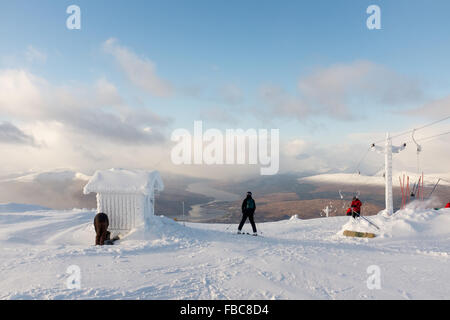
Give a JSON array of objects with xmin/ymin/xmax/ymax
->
[{"xmin": 83, "ymin": 169, "xmax": 164, "ymax": 195}]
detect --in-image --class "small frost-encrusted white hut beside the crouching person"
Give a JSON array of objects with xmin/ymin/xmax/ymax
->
[{"xmin": 83, "ymin": 169, "xmax": 164, "ymax": 235}]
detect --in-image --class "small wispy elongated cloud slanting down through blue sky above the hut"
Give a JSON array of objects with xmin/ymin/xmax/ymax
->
[{"xmin": 103, "ymin": 38, "xmax": 173, "ymax": 97}]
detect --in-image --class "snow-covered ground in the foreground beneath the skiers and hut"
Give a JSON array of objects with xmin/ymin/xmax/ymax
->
[{"xmin": 0, "ymin": 204, "xmax": 450, "ymax": 299}]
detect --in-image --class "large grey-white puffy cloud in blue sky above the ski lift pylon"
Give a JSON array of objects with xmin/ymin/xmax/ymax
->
[{"xmin": 261, "ymin": 61, "xmax": 422, "ymax": 120}]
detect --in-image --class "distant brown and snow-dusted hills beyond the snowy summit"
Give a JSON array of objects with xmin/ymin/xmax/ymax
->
[{"xmin": 0, "ymin": 169, "xmax": 450, "ymax": 223}]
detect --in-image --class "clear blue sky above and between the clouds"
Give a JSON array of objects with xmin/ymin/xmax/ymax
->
[{"xmin": 0, "ymin": 0, "xmax": 450, "ymax": 175}]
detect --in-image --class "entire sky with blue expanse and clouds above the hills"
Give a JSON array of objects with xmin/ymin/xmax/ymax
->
[{"xmin": 0, "ymin": 0, "xmax": 450, "ymax": 179}]
